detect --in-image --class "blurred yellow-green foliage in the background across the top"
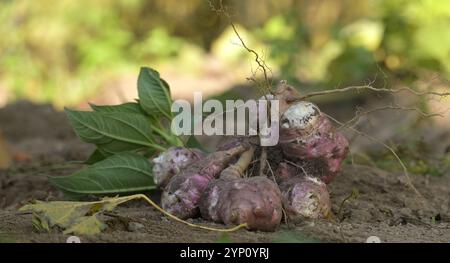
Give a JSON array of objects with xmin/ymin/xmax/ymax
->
[{"xmin": 0, "ymin": 0, "xmax": 450, "ymax": 107}]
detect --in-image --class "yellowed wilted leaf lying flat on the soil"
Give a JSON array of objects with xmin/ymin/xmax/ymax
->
[{"xmin": 20, "ymin": 196, "xmax": 137, "ymax": 235}]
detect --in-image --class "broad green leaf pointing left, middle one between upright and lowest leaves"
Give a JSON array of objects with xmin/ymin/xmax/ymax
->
[{"xmin": 66, "ymin": 109, "xmax": 164, "ymax": 151}]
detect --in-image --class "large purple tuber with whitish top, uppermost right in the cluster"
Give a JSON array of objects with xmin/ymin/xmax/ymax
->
[{"xmin": 279, "ymin": 101, "xmax": 348, "ymax": 183}]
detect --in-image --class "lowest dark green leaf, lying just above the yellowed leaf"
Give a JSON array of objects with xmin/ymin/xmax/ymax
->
[{"xmin": 49, "ymin": 152, "xmax": 156, "ymax": 195}]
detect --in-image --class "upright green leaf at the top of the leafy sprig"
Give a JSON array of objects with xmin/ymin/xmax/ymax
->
[{"xmin": 138, "ymin": 67, "xmax": 172, "ymax": 119}]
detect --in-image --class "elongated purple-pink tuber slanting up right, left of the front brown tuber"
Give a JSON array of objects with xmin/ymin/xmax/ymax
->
[{"xmin": 161, "ymin": 143, "xmax": 248, "ymax": 219}]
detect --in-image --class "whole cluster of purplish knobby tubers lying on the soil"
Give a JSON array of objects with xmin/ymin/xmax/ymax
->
[{"xmin": 153, "ymin": 82, "xmax": 348, "ymax": 231}]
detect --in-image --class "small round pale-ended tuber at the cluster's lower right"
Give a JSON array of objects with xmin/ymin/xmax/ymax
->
[{"xmin": 276, "ymin": 163, "xmax": 331, "ymax": 221}]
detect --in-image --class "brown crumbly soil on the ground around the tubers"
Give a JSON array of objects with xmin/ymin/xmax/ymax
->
[{"xmin": 0, "ymin": 102, "xmax": 450, "ymax": 242}]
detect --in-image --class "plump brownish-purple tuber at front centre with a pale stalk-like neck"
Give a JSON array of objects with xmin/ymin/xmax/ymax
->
[{"xmin": 200, "ymin": 148, "xmax": 282, "ymax": 231}]
